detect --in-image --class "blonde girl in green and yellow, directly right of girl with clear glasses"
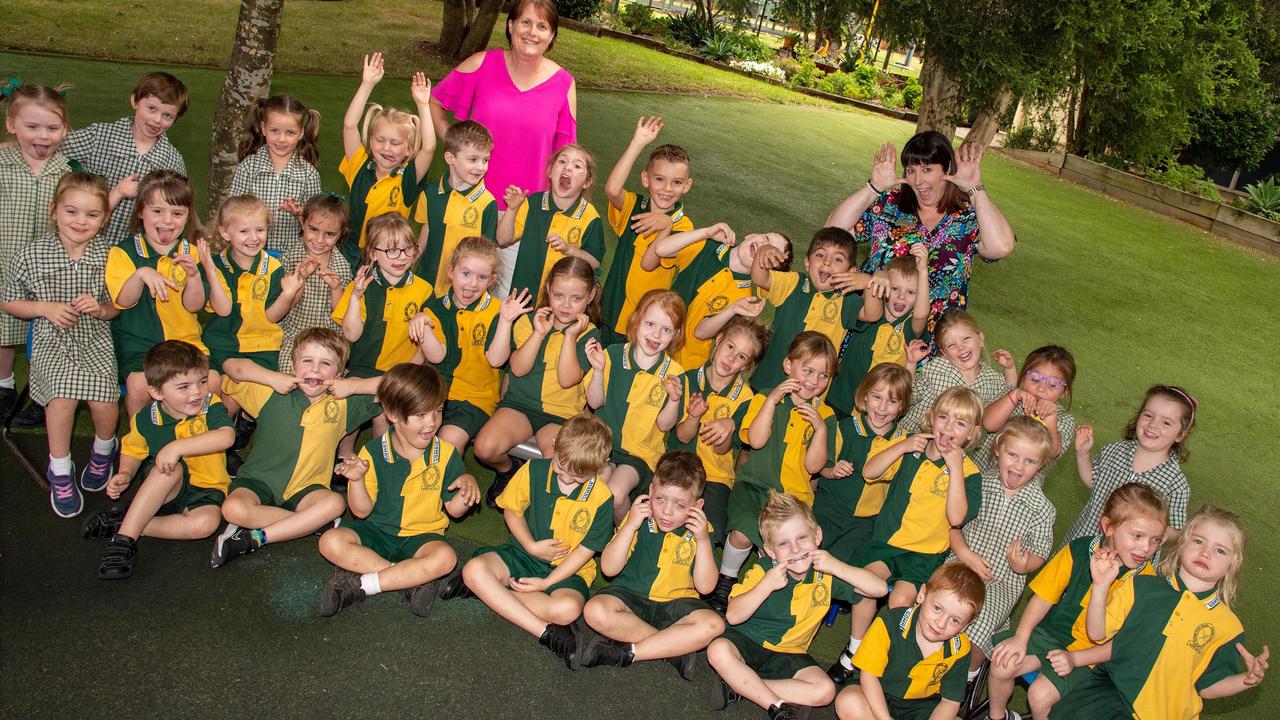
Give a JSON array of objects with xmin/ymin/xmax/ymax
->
[{"xmin": 410, "ymin": 236, "xmax": 504, "ymax": 452}]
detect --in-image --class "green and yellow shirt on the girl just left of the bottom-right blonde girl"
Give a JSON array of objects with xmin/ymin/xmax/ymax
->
[{"xmin": 1028, "ymin": 536, "xmax": 1156, "ymax": 651}]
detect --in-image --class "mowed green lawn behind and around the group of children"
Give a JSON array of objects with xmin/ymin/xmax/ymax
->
[{"xmin": 0, "ymin": 54, "xmax": 1280, "ymax": 717}]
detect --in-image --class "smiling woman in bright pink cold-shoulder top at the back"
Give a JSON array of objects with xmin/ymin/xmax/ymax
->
[{"xmin": 431, "ymin": 0, "xmax": 577, "ymax": 292}]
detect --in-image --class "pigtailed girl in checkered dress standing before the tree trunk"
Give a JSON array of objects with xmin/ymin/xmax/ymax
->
[{"xmin": 230, "ymin": 95, "xmax": 320, "ymax": 258}]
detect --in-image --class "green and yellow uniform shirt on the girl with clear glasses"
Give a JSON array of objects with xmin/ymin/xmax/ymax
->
[{"xmin": 330, "ymin": 265, "xmax": 431, "ymax": 378}]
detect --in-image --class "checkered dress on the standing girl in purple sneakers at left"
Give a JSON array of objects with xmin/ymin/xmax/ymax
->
[{"xmin": 0, "ymin": 233, "xmax": 120, "ymax": 405}]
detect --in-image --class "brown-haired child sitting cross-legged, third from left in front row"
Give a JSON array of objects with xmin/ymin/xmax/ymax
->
[{"xmin": 320, "ymin": 363, "xmax": 480, "ymax": 618}]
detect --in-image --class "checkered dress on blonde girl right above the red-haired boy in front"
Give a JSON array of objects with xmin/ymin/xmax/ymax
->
[{"xmin": 947, "ymin": 471, "xmax": 1057, "ymax": 657}]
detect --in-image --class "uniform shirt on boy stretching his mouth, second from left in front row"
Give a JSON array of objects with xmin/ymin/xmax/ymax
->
[{"xmin": 223, "ymin": 379, "xmax": 383, "ymax": 500}]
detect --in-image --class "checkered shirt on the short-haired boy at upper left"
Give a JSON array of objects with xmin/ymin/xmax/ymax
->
[{"xmin": 61, "ymin": 117, "xmax": 187, "ymax": 245}]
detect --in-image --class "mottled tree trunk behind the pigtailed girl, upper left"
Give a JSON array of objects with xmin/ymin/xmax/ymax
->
[{"xmin": 209, "ymin": 0, "xmax": 284, "ymax": 214}]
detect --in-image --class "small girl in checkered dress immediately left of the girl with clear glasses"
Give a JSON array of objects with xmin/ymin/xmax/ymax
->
[{"xmin": 279, "ymin": 193, "xmax": 351, "ymax": 373}]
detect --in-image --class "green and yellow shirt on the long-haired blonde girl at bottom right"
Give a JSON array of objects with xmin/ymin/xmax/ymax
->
[{"xmin": 1102, "ymin": 575, "xmax": 1244, "ymax": 720}]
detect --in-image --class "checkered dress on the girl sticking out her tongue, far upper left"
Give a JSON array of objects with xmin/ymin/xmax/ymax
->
[{"xmin": 0, "ymin": 147, "xmax": 72, "ymax": 347}]
